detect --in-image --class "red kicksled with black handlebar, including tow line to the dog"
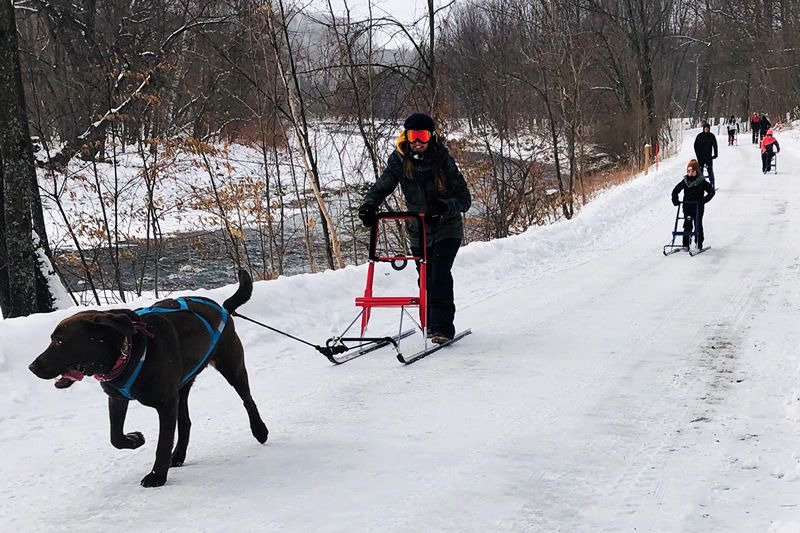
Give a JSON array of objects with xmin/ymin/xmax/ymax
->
[{"xmin": 234, "ymin": 211, "xmax": 472, "ymax": 365}]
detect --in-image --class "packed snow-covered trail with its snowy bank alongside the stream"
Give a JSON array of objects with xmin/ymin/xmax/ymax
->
[{"xmin": 0, "ymin": 127, "xmax": 800, "ymax": 532}]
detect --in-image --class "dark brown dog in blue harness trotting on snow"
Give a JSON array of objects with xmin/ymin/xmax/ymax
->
[{"xmin": 29, "ymin": 270, "xmax": 269, "ymax": 487}]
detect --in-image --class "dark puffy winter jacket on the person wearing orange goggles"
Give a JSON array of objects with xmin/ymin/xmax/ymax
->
[{"xmin": 364, "ymin": 137, "xmax": 472, "ymax": 246}]
